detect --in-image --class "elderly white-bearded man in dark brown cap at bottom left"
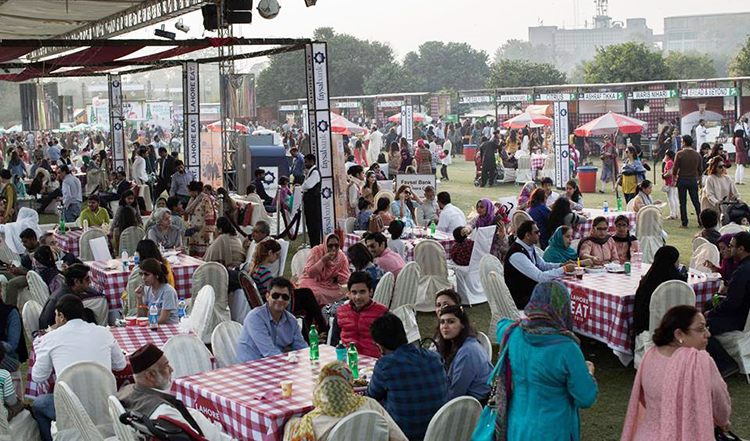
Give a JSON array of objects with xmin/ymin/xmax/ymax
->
[{"xmin": 117, "ymin": 343, "xmax": 232, "ymax": 441}]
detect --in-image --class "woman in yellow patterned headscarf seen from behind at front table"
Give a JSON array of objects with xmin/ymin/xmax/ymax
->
[{"xmin": 284, "ymin": 361, "xmax": 407, "ymax": 441}]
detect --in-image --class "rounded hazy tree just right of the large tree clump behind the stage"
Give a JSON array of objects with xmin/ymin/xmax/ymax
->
[{"xmin": 403, "ymin": 41, "xmax": 489, "ymax": 92}]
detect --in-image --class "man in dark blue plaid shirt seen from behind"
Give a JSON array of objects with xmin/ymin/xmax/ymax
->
[{"xmin": 366, "ymin": 312, "xmax": 448, "ymax": 440}]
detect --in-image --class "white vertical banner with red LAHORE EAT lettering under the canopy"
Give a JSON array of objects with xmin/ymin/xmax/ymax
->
[{"xmin": 182, "ymin": 61, "xmax": 201, "ymax": 181}]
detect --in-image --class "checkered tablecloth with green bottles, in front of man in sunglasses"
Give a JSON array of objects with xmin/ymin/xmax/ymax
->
[{"xmin": 172, "ymin": 345, "xmax": 377, "ymax": 441}]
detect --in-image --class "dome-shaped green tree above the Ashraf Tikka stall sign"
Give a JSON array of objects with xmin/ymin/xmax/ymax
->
[{"xmin": 584, "ymin": 42, "xmax": 669, "ymax": 83}]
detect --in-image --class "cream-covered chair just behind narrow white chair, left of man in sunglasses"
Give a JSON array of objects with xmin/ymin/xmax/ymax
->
[{"xmin": 191, "ymin": 262, "xmax": 232, "ymax": 343}]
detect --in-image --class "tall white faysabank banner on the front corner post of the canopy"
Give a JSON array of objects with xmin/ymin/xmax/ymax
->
[{"xmin": 305, "ymin": 43, "xmax": 336, "ymax": 237}]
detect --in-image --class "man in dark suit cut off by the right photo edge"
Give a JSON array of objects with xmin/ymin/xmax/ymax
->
[{"xmin": 706, "ymin": 231, "xmax": 750, "ymax": 378}]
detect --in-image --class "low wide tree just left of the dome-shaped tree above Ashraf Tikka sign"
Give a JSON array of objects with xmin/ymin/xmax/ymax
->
[{"xmin": 487, "ymin": 60, "xmax": 566, "ymax": 88}]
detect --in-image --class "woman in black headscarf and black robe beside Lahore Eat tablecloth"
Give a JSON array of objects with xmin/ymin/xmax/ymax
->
[{"xmin": 633, "ymin": 245, "xmax": 687, "ymax": 335}]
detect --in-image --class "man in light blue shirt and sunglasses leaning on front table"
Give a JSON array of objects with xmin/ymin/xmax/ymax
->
[{"xmin": 237, "ymin": 277, "xmax": 307, "ymax": 363}]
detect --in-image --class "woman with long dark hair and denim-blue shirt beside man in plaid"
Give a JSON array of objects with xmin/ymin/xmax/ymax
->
[{"xmin": 436, "ymin": 305, "xmax": 492, "ymax": 402}]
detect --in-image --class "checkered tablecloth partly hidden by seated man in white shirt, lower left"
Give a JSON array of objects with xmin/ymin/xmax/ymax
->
[{"xmin": 26, "ymin": 325, "xmax": 191, "ymax": 399}]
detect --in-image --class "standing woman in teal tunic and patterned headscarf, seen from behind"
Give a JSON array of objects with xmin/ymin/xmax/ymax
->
[{"xmin": 490, "ymin": 281, "xmax": 598, "ymax": 441}]
